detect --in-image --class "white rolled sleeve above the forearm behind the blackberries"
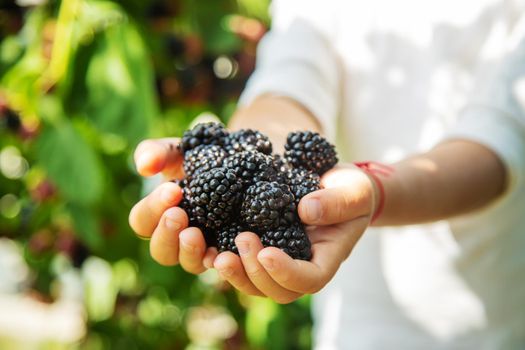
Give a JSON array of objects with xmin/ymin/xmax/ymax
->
[{"xmin": 239, "ymin": 0, "xmax": 341, "ymax": 140}]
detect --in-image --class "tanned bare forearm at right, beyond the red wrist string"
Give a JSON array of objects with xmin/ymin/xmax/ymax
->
[{"xmin": 374, "ymin": 140, "xmax": 506, "ymax": 226}]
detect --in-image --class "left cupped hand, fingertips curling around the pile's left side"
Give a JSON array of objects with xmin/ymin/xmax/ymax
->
[{"xmin": 129, "ymin": 138, "xmax": 217, "ymax": 274}]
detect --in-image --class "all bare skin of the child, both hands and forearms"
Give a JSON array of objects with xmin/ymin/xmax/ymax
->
[{"xmin": 129, "ymin": 95, "xmax": 506, "ymax": 303}]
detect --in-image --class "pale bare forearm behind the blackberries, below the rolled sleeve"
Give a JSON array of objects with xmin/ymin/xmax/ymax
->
[{"xmin": 228, "ymin": 95, "xmax": 321, "ymax": 152}]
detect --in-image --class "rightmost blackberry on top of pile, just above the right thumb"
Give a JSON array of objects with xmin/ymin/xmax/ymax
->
[{"xmin": 284, "ymin": 131, "xmax": 338, "ymax": 175}]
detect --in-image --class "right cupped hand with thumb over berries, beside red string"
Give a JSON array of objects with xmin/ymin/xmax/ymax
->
[{"xmin": 214, "ymin": 165, "xmax": 376, "ymax": 303}]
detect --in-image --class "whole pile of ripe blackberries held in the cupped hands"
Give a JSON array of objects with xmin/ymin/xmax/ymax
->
[{"xmin": 179, "ymin": 123, "xmax": 337, "ymax": 260}]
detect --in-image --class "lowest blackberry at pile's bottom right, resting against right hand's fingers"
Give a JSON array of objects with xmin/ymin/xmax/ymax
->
[{"xmin": 261, "ymin": 223, "xmax": 312, "ymax": 260}]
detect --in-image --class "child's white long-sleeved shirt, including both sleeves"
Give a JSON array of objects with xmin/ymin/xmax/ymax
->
[{"xmin": 240, "ymin": 0, "xmax": 525, "ymax": 349}]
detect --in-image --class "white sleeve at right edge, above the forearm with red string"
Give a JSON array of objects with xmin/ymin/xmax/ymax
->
[{"xmin": 448, "ymin": 21, "xmax": 525, "ymax": 191}]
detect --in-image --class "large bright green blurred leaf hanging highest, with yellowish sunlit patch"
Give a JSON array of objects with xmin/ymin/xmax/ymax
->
[{"xmin": 85, "ymin": 23, "xmax": 158, "ymax": 144}]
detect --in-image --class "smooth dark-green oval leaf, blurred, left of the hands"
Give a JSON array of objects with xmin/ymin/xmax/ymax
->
[{"xmin": 36, "ymin": 121, "xmax": 104, "ymax": 204}]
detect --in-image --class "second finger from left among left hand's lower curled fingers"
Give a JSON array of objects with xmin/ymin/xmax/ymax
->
[{"xmin": 149, "ymin": 207, "xmax": 188, "ymax": 266}]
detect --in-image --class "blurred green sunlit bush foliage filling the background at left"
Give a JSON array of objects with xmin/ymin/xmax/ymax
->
[{"xmin": 0, "ymin": 0, "xmax": 311, "ymax": 349}]
